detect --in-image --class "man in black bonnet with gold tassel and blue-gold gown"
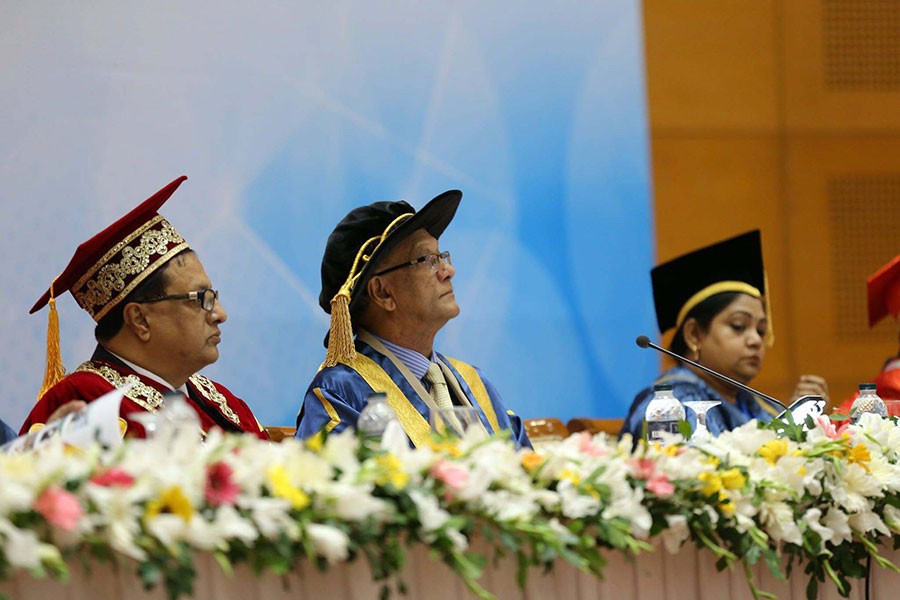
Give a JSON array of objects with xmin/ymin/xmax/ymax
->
[{"xmin": 296, "ymin": 190, "xmax": 531, "ymax": 446}]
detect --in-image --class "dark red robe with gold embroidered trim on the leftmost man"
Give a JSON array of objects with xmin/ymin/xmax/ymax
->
[{"xmin": 19, "ymin": 346, "xmax": 269, "ymax": 440}]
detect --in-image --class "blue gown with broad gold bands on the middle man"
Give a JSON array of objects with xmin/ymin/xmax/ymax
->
[{"xmin": 296, "ymin": 340, "xmax": 531, "ymax": 447}]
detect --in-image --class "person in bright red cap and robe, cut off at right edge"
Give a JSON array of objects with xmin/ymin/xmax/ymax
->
[{"xmin": 836, "ymin": 255, "xmax": 900, "ymax": 415}]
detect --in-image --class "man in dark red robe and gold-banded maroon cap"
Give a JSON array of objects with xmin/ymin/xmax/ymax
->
[{"xmin": 20, "ymin": 176, "xmax": 268, "ymax": 439}]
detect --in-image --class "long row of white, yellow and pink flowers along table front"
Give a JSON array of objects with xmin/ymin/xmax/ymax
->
[{"xmin": 0, "ymin": 415, "xmax": 900, "ymax": 598}]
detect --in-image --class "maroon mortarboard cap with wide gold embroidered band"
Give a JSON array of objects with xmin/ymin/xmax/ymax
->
[{"xmin": 30, "ymin": 175, "xmax": 188, "ymax": 321}]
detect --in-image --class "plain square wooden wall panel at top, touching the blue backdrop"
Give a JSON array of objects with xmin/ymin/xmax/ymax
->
[{"xmin": 644, "ymin": 0, "xmax": 777, "ymax": 132}]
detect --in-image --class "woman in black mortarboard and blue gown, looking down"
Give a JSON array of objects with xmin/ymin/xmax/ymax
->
[{"xmin": 621, "ymin": 230, "xmax": 828, "ymax": 439}]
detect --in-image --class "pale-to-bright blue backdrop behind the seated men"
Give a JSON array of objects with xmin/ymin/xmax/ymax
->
[{"xmin": 0, "ymin": 0, "xmax": 657, "ymax": 425}]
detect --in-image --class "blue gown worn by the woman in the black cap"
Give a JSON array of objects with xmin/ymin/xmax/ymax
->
[{"xmin": 619, "ymin": 366, "xmax": 778, "ymax": 440}]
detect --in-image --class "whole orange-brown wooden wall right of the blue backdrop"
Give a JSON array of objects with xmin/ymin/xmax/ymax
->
[{"xmin": 644, "ymin": 0, "xmax": 900, "ymax": 408}]
